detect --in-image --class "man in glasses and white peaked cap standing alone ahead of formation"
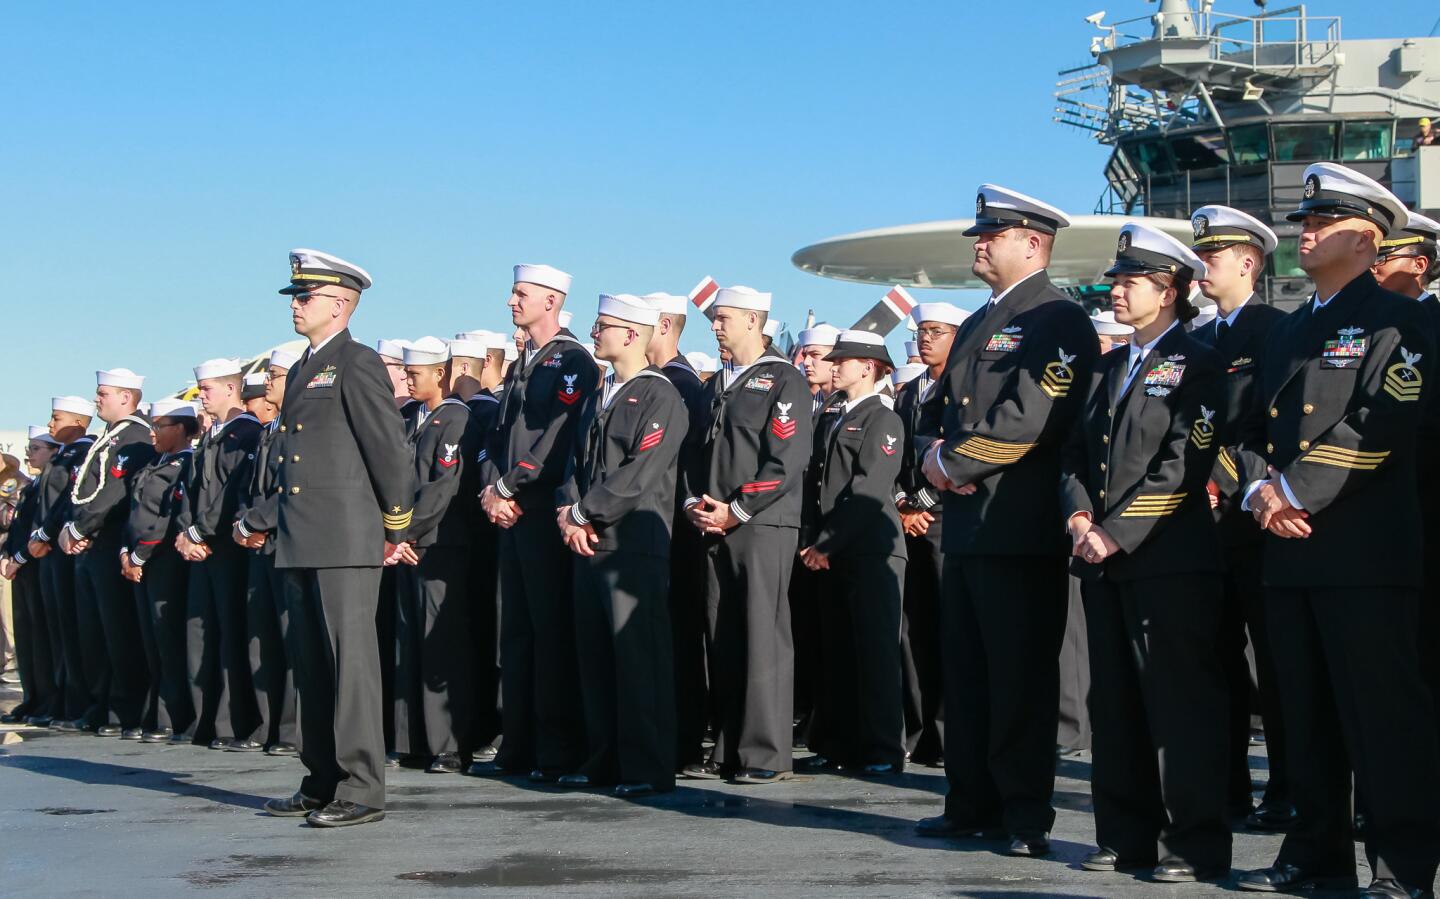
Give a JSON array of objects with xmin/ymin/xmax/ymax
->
[{"xmin": 265, "ymin": 249, "xmax": 415, "ymax": 827}]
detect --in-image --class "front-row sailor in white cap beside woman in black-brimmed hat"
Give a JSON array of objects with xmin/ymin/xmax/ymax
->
[{"xmin": 683, "ymin": 287, "xmax": 811, "ymax": 784}]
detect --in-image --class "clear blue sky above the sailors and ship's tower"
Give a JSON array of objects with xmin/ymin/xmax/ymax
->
[{"xmin": 0, "ymin": 0, "xmax": 1437, "ymax": 429}]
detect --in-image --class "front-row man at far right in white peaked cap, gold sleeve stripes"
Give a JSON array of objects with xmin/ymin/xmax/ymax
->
[{"xmin": 1236, "ymin": 163, "xmax": 1440, "ymax": 896}]
